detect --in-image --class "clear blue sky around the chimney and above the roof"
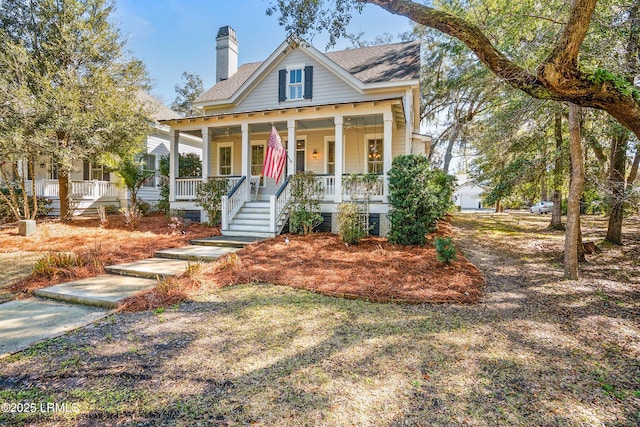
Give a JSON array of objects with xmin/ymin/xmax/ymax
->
[{"xmin": 114, "ymin": 0, "xmax": 411, "ymax": 106}]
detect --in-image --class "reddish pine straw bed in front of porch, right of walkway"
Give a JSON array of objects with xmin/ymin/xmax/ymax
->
[{"xmin": 204, "ymin": 222, "xmax": 485, "ymax": 304}]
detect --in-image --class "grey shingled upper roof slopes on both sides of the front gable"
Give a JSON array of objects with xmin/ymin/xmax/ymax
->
[{"xmin": 196, "ymin": 41, "xmax": 420, "ymax": 102}]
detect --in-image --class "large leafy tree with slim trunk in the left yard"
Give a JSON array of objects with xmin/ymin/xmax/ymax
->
[{"xmin": 0, "ymin": 0, "xmax": 150, "ymax": 217}]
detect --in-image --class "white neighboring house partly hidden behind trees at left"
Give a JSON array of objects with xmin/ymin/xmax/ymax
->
[{"xmin": 22, "ymin": 92, "xmax": 202, "ymax": 215}]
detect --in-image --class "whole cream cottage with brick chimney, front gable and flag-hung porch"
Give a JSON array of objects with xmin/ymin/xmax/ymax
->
[{"xmin": 161, "ymin": 26, "xmax": 430, "ymax": 236}]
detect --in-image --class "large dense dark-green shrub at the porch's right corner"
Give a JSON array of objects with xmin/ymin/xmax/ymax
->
[{"xmin": 389, "ymin": 155, "xmax": 455, "ymax": 245}]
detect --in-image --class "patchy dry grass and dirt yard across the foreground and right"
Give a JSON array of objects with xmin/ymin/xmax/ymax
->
[{"xmin": 0, "ymin": 213, "xmax": 640, "ymax": 426}]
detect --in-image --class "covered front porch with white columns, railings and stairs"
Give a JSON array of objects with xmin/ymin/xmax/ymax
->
[{"xmin": 162, "ymin": 99, "xmax": 411, "ymax": 233}]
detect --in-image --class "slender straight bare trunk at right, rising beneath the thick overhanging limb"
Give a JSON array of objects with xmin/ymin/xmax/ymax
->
[{"xmin": 564, "ymin": 103, "xmax": 584, "ymax": 280}]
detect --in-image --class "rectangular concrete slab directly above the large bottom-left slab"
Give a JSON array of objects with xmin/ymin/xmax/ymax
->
[{"xmin": 34, "ymin": 275, "xmax": 157, "ymax": 308}]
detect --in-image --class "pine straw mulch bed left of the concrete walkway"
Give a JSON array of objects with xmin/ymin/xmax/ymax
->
[{"xmin": 0, "ymin": 215, "xmax": 220, "ymax": 297}]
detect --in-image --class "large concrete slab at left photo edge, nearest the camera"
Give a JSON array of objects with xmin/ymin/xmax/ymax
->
[{"xmin": 0, "ymin": 298, "xmax": 111, "ymax": 358}]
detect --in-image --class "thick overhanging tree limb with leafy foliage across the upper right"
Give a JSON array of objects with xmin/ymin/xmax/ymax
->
[{"xmin": 267, "ymin": 0, "xmax": 640, "ymax": 141}]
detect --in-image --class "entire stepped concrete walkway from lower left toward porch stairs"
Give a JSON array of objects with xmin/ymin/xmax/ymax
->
[{"xmin": 0, "ymin": 236, "xmax": 256, "ymax": 359}]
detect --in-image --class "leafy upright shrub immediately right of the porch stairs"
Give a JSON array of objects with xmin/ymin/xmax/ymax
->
[{"xmin": 289, "ymin": 172, "xmax": 323, "ymax": 234}]
